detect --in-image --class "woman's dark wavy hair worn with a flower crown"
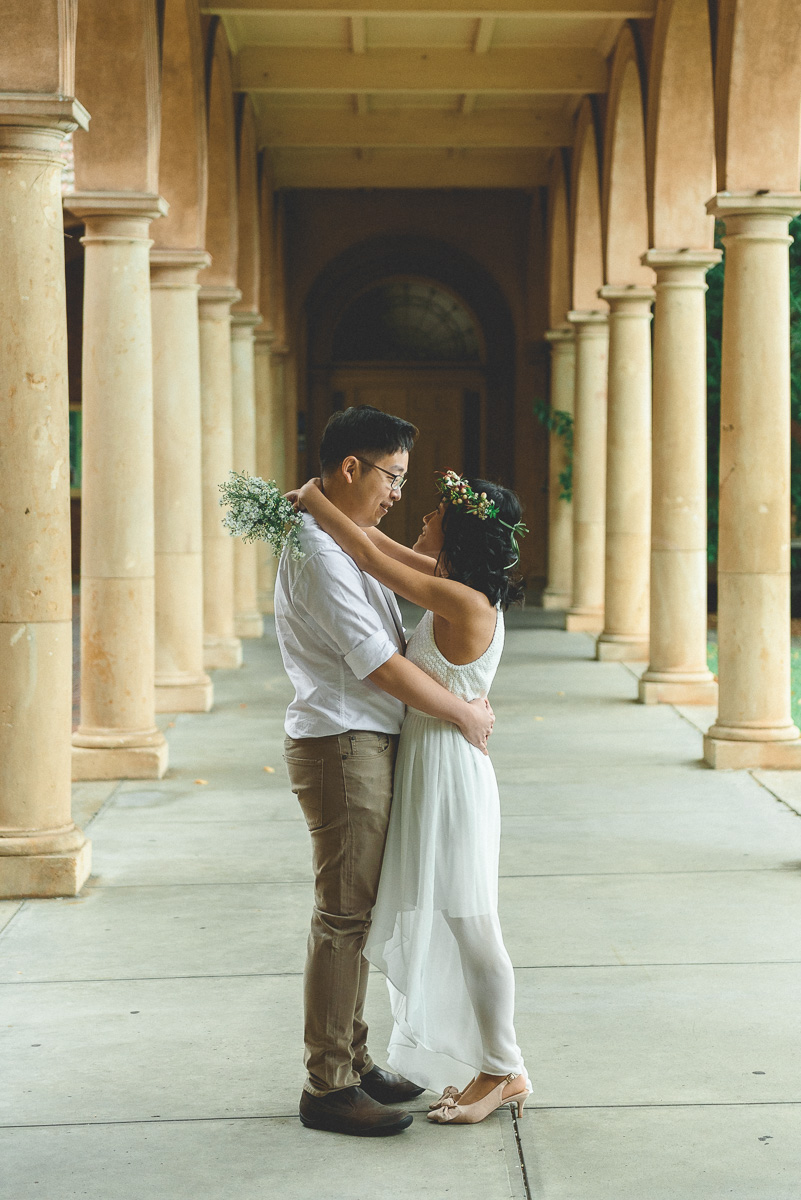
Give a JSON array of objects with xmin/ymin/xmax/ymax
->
[{"xmin": 440, "ymin": 476, "xmax": 524, "ymax": 612}]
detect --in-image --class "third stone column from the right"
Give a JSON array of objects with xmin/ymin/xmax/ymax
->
[{"xmin": 596, "ymin": 284, "xmax": 655, "ymax": 662}]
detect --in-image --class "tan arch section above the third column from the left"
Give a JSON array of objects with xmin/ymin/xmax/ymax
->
[{"xmin": 152, "ymin": 0, "xmax": 209, "ymax": 251}]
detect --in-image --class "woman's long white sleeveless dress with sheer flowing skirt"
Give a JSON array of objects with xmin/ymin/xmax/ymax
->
[{"xmin": 365, "ymin": 610, "xmax": 525, "ymax": 1092}]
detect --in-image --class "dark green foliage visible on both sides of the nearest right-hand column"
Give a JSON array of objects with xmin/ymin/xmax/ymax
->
[{"xmin": 706, "ymin": 217, "xmax": 801, "ymax": 563}]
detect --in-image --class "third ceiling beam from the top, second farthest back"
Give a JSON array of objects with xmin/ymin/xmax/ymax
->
[{"xmin": 259, "ymin": 107, "xmax": 573, "ymax": 150}]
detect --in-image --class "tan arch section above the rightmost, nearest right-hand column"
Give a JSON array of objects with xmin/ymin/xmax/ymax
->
[{"xmin": 715, "ymin": 0, "xmax": 801, "ymax": 192}]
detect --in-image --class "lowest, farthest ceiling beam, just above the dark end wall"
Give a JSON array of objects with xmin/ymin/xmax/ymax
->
[{"xmin": 272, "ymin": 150, "xmax": 548, "ymax": 190}]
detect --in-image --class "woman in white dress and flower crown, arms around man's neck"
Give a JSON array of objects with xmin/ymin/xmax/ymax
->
[{"xmin": 299, "ymin": 472, "xmax": 530, "ymax": 1124}]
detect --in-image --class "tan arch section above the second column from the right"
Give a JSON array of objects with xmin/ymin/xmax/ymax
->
[{"xmin": 646, "ymin": 0, "xmax": 715, "ymax": 250}]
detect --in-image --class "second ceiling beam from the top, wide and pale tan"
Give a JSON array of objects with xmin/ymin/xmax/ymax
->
[{"xmin": 234, "ymin": 46, "xmax": 608, "ymax": 95}]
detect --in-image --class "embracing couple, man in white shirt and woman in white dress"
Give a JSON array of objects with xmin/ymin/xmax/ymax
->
[{"xmin": 276, "ymin": 406, "xmax": 530, "ymax": 1136}]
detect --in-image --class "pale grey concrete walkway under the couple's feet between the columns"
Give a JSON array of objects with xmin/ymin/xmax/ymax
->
[{"xmin": 0, "ymin": 614, "xmax": 801, "ymax": 1200}]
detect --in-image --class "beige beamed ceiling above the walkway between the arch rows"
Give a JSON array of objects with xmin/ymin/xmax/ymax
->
[{"xmin": 201, "ymin": 0, "xmax": 656, "ymax": 188}]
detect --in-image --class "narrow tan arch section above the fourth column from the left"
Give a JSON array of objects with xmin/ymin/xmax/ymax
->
[{"xmin": 203, "ymin": 17, "xmax": 239, "ymax": 287}]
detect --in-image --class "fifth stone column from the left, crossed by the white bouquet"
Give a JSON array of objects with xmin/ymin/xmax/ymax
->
[{"xmin": 231, "ymin": 312, "xmax": 264, "ymax": 637}]
